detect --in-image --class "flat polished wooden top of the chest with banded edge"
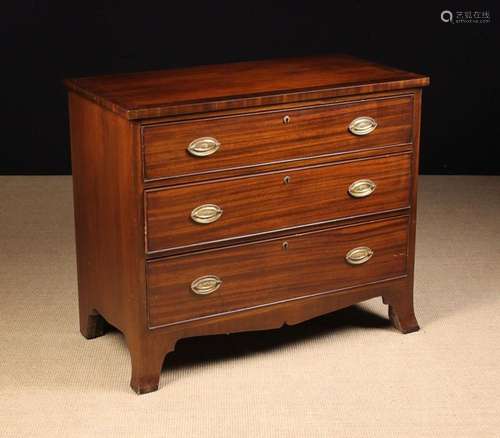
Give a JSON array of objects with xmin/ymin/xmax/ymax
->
[{"xmin": 65, "ymin": 55, "xmax": 429, "ymax": 120}]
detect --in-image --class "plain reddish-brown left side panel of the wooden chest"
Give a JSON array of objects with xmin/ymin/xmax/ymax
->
[{"xmin": 69, "ymin": 93, "xmax": 145, "ymax": 338}]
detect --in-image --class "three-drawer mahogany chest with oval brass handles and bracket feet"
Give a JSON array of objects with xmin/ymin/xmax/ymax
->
[{"xmin": 66, "ymin": 55, "xmax": 429, "ymax": 393}]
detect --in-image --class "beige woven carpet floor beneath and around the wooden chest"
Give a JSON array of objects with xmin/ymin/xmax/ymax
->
[{"xmin": 0, "ymin": 176, "xmax": 500, "ymax": 438}]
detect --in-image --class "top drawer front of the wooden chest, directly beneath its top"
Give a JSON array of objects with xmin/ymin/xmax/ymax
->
[{"xmin": 143, "ymin": 96, "xmax": 413, "ymax": 179}]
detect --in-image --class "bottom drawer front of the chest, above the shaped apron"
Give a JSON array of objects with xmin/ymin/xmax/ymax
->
[{"xmin": 147, "ymin": 216, "xmax": 408, "ymax": 327}]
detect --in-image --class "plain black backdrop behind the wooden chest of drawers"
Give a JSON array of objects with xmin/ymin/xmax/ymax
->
[{"xmin": 0, "ymin": 0, "xmax": 500, "ymax": 174}]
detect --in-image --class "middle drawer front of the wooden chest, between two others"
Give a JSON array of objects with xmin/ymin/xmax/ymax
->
[{"xmin": 145, "ymin": 154, "xmax": 411, "ymax": 252}]
